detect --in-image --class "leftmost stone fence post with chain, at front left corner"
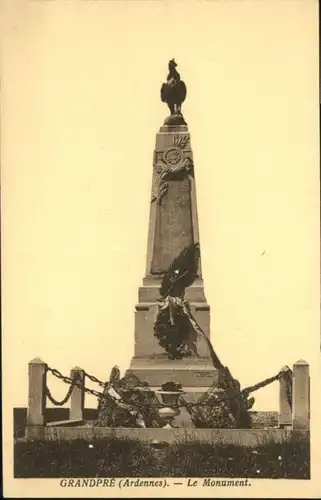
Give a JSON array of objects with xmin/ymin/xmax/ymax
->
[{"xmin": 26, "ymin": 358, "xmax": 47, "ymax": 438}]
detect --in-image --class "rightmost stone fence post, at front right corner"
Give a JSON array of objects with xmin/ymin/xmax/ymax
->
[{"xmin": 292, "ymin": 359, "xmax": 310, "ymax": 430}]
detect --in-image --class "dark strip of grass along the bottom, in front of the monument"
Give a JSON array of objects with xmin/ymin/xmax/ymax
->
[{"xmin": 14, "ymin": 437, "xmax": 310, "ymax": 479}]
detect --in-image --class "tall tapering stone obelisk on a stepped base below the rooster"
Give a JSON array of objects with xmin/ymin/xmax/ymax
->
[{"xmin": 127, "ymin": 60, "xmax": 219, "ymax": 400}]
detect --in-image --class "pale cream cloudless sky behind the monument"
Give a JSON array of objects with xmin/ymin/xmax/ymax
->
[{"xmin": 1, "ymin": 0, "xmax": 320, "ymax": 418}]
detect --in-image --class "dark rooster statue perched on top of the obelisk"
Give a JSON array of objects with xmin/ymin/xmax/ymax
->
[{"xmin": 161, "ymin": 59, "xmax": 187, "ymax": 124}]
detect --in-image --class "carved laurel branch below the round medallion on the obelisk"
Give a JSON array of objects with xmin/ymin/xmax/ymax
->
[{"xmin": 151, "ymin": 157, "xmax": 194, "ymax": 203}]
